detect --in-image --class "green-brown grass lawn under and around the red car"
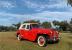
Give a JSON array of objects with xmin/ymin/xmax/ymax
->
[{"xmin": 0, "ymin": 32, "xmax": 72, "ymax": 50}]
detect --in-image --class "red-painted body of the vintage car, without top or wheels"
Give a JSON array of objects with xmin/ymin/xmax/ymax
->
[{"xmin": 17, "ymin": 28, "xmax": 58, "ymax": 41}]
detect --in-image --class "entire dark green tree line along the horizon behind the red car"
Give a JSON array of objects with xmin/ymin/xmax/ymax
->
[{"xmin": 0, "ymin": 19, "xmax": 72, "ymax": 32}]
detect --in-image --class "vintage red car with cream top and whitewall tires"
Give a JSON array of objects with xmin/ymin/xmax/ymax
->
[{"xmin": 16, "ymin": 23, "xmax": 59, "ymax": 46}]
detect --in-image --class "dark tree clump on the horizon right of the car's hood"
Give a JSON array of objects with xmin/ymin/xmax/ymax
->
[{"xmin": 53, "ymin": 21, "xmax": 70, "ymax": 31}]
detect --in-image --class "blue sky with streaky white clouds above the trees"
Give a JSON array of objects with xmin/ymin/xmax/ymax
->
[{"xmin": 0, "ymin": 0, "xmax": 72, "ymax": 25}]
